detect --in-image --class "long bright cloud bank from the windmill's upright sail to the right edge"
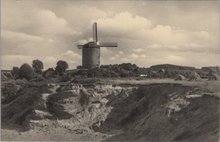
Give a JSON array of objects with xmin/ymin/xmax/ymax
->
[{"xmin": 94, "ymin": 12, "xmax": 218, "ymax": 52}]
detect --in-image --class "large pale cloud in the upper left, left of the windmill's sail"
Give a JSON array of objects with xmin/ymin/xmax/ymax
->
[{"xmin": 2, "ymin": 6, "xmax": 76, "ymax": 35}]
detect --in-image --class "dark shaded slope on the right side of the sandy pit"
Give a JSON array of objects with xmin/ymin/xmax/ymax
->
[{"xmin": 96, "ymin": 84, "xmax": 219, "ymax": 142}]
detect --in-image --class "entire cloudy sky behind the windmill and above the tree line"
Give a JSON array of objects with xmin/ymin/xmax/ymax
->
[{"xmin": 1, "ymin": 0, "xmax": 220, "ymax": 69}]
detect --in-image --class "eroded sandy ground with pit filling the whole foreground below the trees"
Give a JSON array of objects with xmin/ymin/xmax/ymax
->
[{"xmin": 1, "ymin": 78, "xmax": 220, "ymax": 142}]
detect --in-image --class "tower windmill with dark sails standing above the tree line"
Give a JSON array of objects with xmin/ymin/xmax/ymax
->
[{"xmin": 77, "ymin": 23, "xmax": 117, "ymax": 69}]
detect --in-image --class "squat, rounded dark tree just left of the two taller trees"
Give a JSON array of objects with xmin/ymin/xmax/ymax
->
[{"xmin": 19, "ymin": 64, "xmax": 34, "ymax": 80}]
